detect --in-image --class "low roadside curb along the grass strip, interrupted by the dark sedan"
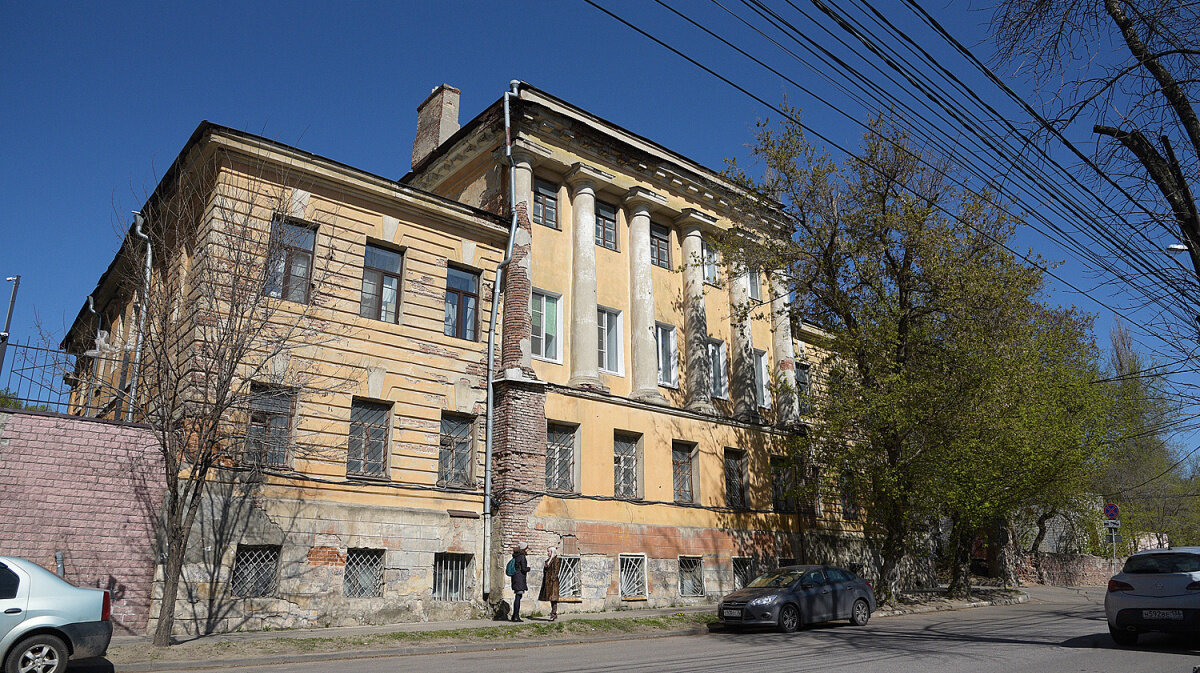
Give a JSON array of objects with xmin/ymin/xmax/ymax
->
[{"xmin": 103, "ymin": 591, "xmax": 1030, "ymax": 673}]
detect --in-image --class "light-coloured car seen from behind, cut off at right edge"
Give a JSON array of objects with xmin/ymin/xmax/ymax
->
[{"xmin": 1104, "ymin": 547, "xmax": 1200, "ymax": 645}]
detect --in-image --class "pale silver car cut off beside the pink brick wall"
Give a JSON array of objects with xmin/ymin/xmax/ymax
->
[{"xmin": 0, "ymin": 557, "xmax": 113, "ymax": 673}]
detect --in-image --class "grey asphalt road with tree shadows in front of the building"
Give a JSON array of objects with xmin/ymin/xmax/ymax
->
[{"xmin": 112, "ymin": 587, "xmax": 1200, "ymax": 673}]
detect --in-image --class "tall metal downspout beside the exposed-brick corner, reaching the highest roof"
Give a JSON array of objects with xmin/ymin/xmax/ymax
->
[{"xmin": 484, "ymin": 79, "xmax": 521, "ymax": 600}]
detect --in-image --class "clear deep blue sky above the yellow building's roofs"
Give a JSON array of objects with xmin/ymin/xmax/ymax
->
[{"xmin": 0, "ymin": 0, "xmax": 1161, "ymax": 374}]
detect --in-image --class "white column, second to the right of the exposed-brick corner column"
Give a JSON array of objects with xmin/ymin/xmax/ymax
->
[{"xmin": 625, "ymin": 187, "xmax": 667, "ymax": 404}]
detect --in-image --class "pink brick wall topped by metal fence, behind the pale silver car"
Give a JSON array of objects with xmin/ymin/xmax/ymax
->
[{"xmin": 0, "ymin": 409, "xmax": 162, "ymax": 633}]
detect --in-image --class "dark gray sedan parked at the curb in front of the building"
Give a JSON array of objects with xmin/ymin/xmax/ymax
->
[{"xmin": 716, "ymin": 565, "xmax": 875, "ymax": 633}]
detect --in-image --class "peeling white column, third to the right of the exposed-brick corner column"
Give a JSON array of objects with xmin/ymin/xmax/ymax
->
[{"xmin": 677, "ymin": 209, "xmax": 716, "ymax": 414}]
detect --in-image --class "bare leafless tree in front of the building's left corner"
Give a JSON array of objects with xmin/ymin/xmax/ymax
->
[{"xmin": 77, "ymin": 137, "xmax": 348, "ymax": 645}]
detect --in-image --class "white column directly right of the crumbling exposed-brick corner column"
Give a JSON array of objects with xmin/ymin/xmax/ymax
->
[{"xmin": 566, "ymin": 163, "xmax": 602, "ymax": 387}]
